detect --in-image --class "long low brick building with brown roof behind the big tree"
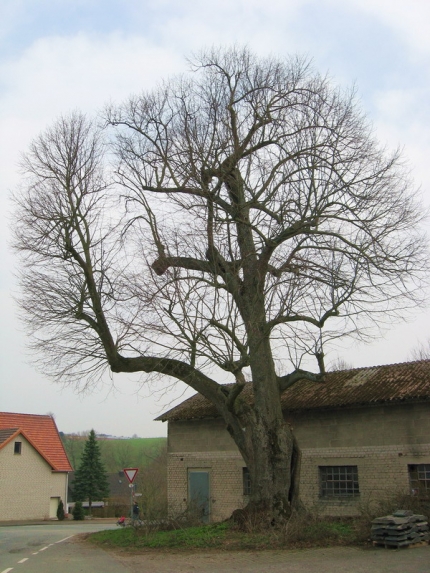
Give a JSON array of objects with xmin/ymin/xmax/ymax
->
[{"xmin": 157, "ymin": 360, "xmax": 430, "ymax": 521}]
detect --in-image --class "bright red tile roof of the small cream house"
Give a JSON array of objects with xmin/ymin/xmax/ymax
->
[{"xmin": 0, "ymin": 412, "xmax": 72, "ymax": 472}]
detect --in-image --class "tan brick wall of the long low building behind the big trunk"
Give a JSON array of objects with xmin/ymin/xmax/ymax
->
[{"xmin": 168, "ymin": 403, "xmax": 430, "ymax": 521}]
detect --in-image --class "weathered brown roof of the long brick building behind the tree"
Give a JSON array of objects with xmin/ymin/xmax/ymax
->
[{"xmin": 157, "ymin": 360, "xmax": 430, "ymax": 422}]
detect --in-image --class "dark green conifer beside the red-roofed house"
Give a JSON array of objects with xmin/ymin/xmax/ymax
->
[{"xmin": 74, "ymin": 430, "xmax": 109, "ymax": 514}]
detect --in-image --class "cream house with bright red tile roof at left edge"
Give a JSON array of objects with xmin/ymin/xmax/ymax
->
[{"xmin": 0, "ymin": 412, "xmax": 72, "ymax": 521}]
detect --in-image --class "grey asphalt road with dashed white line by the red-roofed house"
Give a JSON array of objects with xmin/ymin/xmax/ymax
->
[{"xmin": 0, "ymin": 522, "xmax": 124, "ymax": 573}]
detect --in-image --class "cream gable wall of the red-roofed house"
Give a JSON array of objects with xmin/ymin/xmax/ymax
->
[{"xmin": 0, "ymin": 436, "xmax": 67, "ymax": 521}]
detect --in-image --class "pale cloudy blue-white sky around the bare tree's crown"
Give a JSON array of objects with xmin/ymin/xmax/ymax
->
[{"xmin": 0, "ymin": 0, "xmax": 430, "ymax": 437}]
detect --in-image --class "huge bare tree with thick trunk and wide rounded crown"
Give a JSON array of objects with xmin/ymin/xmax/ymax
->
[{"xmin": 11, "ymin": 49, "xmax": 427, "ymax": 519}]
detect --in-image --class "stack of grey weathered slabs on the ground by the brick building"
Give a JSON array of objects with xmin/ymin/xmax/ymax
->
[{"xmin": 370, "ymin": 510, "xmax": 430, "ymax": 548}]
